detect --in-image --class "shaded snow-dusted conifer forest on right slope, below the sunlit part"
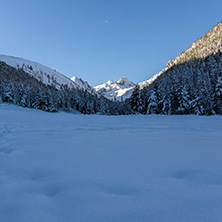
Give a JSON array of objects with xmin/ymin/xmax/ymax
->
[{"xmin": 128, "ymin": 51, "xmax": 222, "ymax": 115}]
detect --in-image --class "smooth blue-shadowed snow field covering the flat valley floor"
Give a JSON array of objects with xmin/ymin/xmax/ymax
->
[{"xmin": 0, "ymin": 104, "xmax": 222, "ymax": 222}]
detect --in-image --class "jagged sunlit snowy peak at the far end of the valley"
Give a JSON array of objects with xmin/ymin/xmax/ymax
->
[{"xmin": 94, "ymin": 77, "xmax": 135, "ymax": 101}]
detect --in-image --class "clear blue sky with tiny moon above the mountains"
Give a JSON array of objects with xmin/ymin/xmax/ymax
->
[{"xmin": 0, "ymin": 0, "xmax": 222, "ymax": 86}]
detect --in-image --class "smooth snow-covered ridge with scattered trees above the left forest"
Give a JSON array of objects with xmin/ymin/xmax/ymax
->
[{"xmin": 0, "ymin": 55, "xmax": 98, "ymax": 95}]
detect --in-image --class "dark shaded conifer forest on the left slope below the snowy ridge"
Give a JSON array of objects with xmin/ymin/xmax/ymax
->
[{"xmin": 0, "ymin": 62, "xmax": 126, "ymax": 115}]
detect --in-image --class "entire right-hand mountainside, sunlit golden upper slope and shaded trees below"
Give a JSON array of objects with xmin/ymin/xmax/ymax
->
[{"xmin": 127, "ymin": 22, "xmax": 222, "ymax": 115}]
